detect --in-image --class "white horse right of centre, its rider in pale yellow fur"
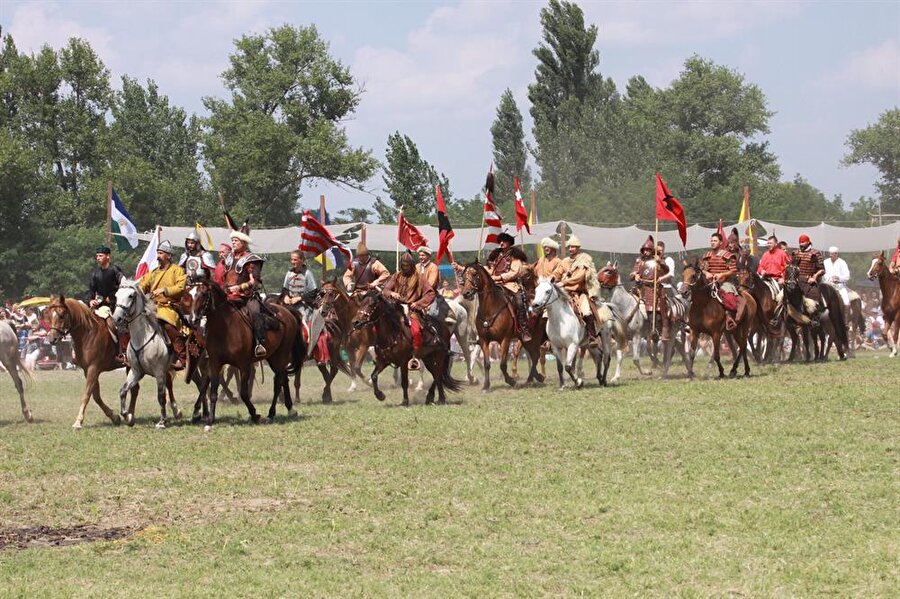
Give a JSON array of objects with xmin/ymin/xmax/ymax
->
[{"xmin": 529, "ymin": 277, "xmax": 612, "ymax": 389}]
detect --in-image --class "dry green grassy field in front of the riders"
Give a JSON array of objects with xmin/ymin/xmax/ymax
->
[{"xmin": 0, "ymin": 353, "xmax": 900, "ymax": 597}]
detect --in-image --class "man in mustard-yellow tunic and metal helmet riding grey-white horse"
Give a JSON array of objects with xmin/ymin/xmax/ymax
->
[{"xmin": 138, "ymin": 240, "xmax": 187, "ymax": 370}]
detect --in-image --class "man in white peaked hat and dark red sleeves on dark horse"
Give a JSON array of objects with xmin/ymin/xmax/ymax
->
[{"xmin": 224, "ymin": 223, "xmax": 266, "ymax": 358}]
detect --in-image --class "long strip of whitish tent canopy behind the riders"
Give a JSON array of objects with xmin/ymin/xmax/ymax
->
[{"xmin": 138, "ymin": 221, "xmax": 900, "ymax": 254}]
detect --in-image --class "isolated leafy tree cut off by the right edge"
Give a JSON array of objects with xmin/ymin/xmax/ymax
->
[{"xmin": 841, "ymin": 108, "xmax": 900, "ymax": 214}]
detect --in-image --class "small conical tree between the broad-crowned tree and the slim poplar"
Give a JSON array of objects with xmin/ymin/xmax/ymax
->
[{"xmin": 375, "ymin": 131, "xmax": 452, "ymax": 224}]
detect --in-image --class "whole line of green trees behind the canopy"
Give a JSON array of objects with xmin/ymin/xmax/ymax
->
[{"xmin": 0, "ymin": 0, "xmax": 900, "ymax": 298}]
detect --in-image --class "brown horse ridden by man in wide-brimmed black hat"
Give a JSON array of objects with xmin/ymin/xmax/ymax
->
[{"xmin": 462, "ymin": 260, "xmax": 544, "ymax": 393}]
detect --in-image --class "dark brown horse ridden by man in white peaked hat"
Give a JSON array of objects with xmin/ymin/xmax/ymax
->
[{"xmin": 188, "ymin": 282, "xmax": 306, "ymax": 431}]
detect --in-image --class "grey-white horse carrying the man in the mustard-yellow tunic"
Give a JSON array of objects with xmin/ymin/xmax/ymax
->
[{"xmin": 113, "ymin": 279, "xmax": 181, "ymax": 428}]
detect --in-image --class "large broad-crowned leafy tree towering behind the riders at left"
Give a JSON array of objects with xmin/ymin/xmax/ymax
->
[{"xmin": 203, "ymin": 25, "xmax": 378, "ymax": 225}]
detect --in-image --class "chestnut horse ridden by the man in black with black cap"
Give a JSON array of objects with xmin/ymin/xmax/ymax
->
[{"xmin": 44, "ymin": 295, "xmax": 126, "ymax": 430}]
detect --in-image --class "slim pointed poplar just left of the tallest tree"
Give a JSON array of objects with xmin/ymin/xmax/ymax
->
[{"xmin": 491, "ymin": 88, "xmax": 531, "ymax": 209}]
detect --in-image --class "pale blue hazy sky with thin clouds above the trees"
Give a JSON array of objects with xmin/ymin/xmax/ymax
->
[{"xmin": 0, "ymin": 0, "xmax": 900, "ymax": 219}]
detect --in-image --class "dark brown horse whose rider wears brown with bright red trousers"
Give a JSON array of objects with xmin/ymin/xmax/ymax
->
[{"xmin": 353, "ymin": 289, "xmax": 462, "ymax": 406}]
